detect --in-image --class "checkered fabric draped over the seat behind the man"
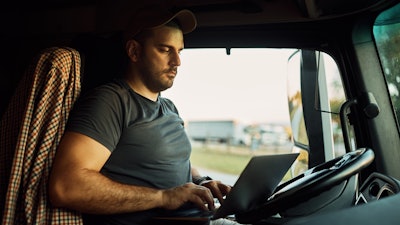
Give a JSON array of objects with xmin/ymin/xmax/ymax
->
[{"xmin": 0, "ymin": 47, "xmax": 82, "ymax": 225}]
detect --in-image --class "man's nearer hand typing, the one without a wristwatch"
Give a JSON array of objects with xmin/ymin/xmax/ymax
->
[{"xmin": 162, "ymin": 183, "xmax": 215, "ymax": 210}]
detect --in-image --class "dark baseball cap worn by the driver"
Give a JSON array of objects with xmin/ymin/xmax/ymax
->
[{"xmin": 125, "ymin": 7, "xmax": 197, "ymax": 39}]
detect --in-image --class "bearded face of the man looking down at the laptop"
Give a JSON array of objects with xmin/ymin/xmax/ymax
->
[{"xmin": 138, "ymin": 26, "xmax": 184, "ymax": 93}]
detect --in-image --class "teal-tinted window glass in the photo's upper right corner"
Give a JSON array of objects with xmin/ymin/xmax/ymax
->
[{"xmin": 373, "ymin": 4, "xmax": 400, "ymax": 126}]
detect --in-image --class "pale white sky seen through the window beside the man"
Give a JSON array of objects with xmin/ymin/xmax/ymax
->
[{"xmin": 162, "ymin": 49, "xmax": 294, "ymax": 124}]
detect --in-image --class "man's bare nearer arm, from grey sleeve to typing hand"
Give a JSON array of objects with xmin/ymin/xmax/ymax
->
[{"xmin": 49, "ymin": 132, "xmax": 214, "ymax": 214}]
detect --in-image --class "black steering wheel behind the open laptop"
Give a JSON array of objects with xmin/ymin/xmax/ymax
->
[{"xmin": 236, "ymin": 148, "xmax": 375, "ymax": 223}]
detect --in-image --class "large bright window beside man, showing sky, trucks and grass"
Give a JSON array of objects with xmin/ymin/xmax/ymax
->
[{"xmin": 162, "ymin": 49, "xmax": 295, "ymax": 184}]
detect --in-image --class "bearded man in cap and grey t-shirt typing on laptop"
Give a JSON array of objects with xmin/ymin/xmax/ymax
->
[{"xmin": 49, "ymin": 6, "xmax": 234, "ymax": 224}]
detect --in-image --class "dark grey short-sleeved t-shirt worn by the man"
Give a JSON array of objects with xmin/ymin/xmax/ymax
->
[{"xmin": 67, "ymin": 80, "xmax": 192, "ymax": 224}]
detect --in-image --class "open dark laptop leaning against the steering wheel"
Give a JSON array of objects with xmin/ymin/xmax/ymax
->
[{"xmin": 152, "ymin": 153, "xmax": 299, "ymax": 220}]
